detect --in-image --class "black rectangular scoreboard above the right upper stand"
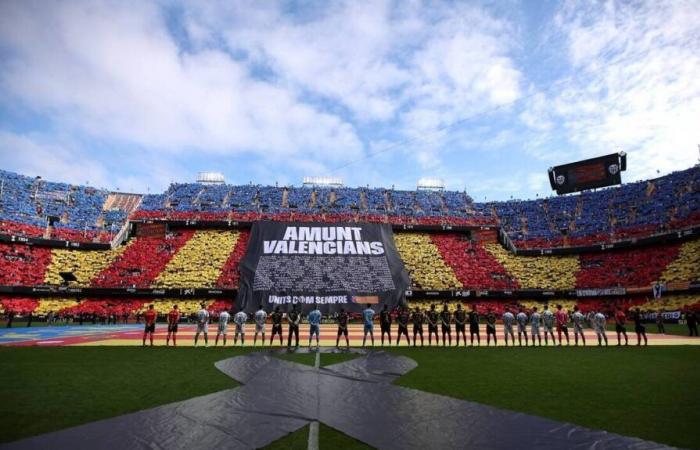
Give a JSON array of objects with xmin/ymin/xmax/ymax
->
[{"xmin": 548, "ymin": 152, "xmax": 627, "ymax": 195}]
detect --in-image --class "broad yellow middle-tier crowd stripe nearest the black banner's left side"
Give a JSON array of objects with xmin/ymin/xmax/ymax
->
[{"xmin": 154, "ymin": 230, "xmax": 240, "ymax": 288}]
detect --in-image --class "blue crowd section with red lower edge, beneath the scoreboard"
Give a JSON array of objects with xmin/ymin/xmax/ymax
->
[{"xmin": 489, "ymin": 166, "xmax": 700, "ymax": 248}]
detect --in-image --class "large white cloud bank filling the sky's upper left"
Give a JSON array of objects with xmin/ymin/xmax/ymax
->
[{"xmin": 0, "ymin": 2, "xmax": 362, "ymax": 160}]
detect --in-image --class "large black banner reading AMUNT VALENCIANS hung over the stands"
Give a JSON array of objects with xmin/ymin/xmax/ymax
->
[{"xmin": 237, "ymin": 222, "xmax": 409, "ymax": 313}]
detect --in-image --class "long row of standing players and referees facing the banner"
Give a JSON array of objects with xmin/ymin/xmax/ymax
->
[{"xmin": 143, "ymin": 304, "xmax": 647, "ymax": 347}]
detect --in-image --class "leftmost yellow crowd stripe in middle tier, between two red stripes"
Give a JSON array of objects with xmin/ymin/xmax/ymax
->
[{"xmin": 44, "ymin": 241, "xmax": 133, "ymax": 286}]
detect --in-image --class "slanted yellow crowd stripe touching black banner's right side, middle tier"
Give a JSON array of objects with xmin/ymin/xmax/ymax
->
[{"xmin": 394, "ymin": 233, "xmax": 462, "ymax": 290}]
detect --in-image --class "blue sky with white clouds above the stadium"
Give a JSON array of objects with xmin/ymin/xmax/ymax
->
[{"xmin": 0, "ymin": 0, "xmax": 700, "ymax": 201}]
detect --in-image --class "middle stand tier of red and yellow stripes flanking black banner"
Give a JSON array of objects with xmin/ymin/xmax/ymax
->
[{"xmin": 0, "ymin": 234, "xmax": 700, "ymax": 291}]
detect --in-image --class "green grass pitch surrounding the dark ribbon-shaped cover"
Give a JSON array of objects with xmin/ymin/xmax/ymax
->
[{"xmin": 0, "ymin": 346, "xmax": 700, "ymax": 448}]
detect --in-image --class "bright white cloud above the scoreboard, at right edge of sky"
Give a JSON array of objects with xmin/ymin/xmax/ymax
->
[{"xmin": 521, "ymin": 0, "xmax": 700, "ymax": 179}]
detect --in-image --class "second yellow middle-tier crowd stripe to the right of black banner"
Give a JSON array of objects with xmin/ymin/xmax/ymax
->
[{"xmin": 486, "ymin": 244, "xmax": 580, "ymax": 289}]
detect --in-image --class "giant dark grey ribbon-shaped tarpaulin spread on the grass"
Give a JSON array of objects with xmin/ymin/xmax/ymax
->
[{"xmin": 2, "ymin": 352, "xmax": 667, "ymax": 450}]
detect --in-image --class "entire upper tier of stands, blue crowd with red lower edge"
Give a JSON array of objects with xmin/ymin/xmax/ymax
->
[{"xmin": 0, "ymin": 166, "xmax": 700, "ymax": 249}]
